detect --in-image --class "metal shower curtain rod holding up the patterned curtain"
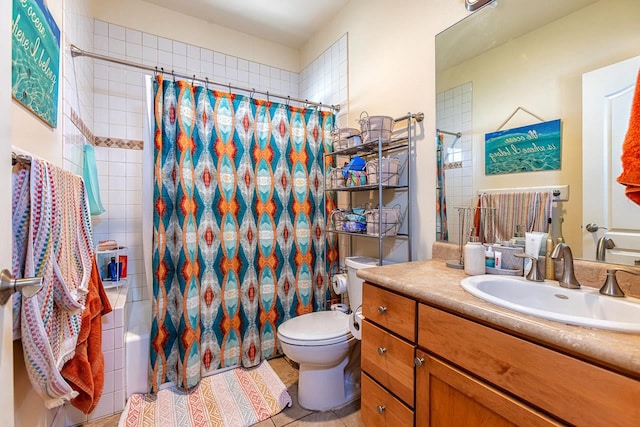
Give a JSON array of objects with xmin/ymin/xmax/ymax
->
[{"xmin": 69, "ymin": 44, "xmax": 340, "ymax": 112}]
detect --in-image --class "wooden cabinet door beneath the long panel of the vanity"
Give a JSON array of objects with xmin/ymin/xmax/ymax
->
[{"xmin": 416, "ymin": 350, "xmax": 561, "ymax": 427}]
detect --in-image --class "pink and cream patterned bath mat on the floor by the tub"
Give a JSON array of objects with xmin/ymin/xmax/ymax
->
[{"xmin": 118, "ymin": 360, "xmax": 292, "ymax": 427}]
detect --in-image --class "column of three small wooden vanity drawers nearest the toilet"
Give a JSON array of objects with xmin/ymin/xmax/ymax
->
[{"xmin": 360, "ymin": 283, "xmax": 417, "ymax": 427}]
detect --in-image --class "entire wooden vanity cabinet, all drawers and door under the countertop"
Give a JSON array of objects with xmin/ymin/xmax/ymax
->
[{"xmin": 360, "ymin": 283, "xmax": 640, "ymax": 427}]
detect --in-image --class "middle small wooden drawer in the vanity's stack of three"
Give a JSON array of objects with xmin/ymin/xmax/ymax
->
[{"xmin": 360, "ymin": 319, "xmax": 415, "ymax": 407}]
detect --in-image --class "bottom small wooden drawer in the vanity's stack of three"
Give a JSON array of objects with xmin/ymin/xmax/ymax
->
[{"xmin": 360, "ymin": 374, "xmax": 413, "ymax": 427}]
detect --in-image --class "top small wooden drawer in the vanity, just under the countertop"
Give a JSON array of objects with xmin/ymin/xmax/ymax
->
[{"xmin": 362, "ymin": 282, "xmax": 417, "ymax": 341}]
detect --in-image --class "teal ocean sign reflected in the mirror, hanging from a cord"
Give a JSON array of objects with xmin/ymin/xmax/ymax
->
[{"xmin": 484, "ymin": 119, "xmax": 562, "ymax": 175}]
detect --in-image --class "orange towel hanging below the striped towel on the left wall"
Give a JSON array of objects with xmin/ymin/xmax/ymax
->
[{"xmin": 62, "ymin": 256, "xmax": 111, "ymax": 414}]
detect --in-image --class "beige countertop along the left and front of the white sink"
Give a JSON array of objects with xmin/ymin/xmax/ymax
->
[{"xmin": 358, "ymin": 259, "xmax": 640, "ymax": 379}]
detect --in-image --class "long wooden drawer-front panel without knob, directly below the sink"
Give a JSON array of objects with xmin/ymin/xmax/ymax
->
[{"xmin": 418, "ymin": 304, "xmax": 640, "ymax": 426}]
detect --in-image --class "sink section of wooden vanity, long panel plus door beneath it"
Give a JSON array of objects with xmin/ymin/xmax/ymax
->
[{"xmin": 416, "ymin": 304, "xmax": 640, "ymax": 427}]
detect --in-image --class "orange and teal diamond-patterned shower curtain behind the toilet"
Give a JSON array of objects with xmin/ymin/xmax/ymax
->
[{"xmin": 150, "ymin": 76, "xmax": 338, "ymax": 391}]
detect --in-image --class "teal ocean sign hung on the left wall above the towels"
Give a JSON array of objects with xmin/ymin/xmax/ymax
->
[{"xmin": 11, "ymin": 0, "xmax": 60, "ymax": 128}]
